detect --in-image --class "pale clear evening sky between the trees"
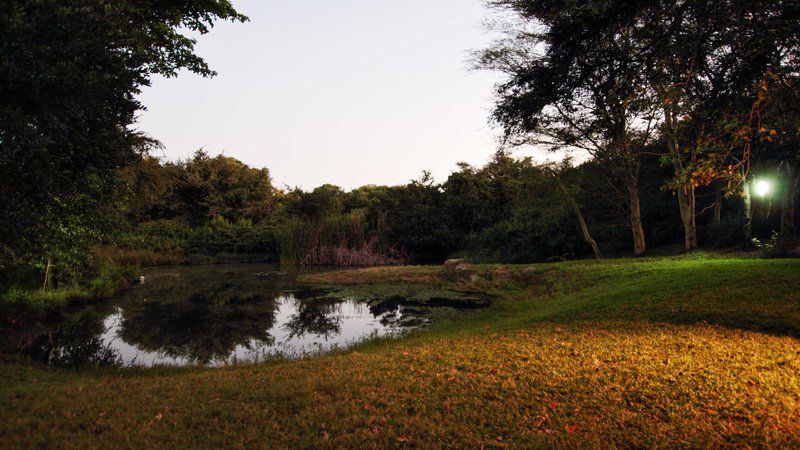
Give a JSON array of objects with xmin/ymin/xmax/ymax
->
[{"xmin": 131, "ymin": 0, "xmax": 500, "ymax": 189}]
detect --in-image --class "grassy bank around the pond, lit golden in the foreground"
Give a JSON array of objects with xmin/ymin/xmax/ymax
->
[{"xmin": 0, "ymin": 255, "xmax": 800, "ymax": 448}]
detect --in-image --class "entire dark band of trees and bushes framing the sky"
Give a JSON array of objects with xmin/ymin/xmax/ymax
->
[{"xmin": 0, "ymin": 0, "xmax": 800, "ymax": 296}]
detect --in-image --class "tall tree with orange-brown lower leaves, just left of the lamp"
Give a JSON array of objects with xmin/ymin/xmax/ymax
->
[{"xmin": 564, "ymin": 0, "xmax": 800, "ymax": 250}]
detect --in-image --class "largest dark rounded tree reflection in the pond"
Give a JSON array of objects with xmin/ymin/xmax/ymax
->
[{"xmin": 119, "ymin": 273, "xmax": 278, "ymax": 364}]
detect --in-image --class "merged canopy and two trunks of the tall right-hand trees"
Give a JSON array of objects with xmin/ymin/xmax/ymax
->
[{"xmin": 478, "ymin": 0, "xmax": 800, "ymax": 253}]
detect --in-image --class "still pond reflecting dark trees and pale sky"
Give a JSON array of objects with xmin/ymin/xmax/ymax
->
[{"xmin": 9, "ymin": 264, "xmax": 488, "ymax": 367}]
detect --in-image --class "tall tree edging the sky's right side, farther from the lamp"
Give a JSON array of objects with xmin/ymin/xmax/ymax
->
[{"xmin": 478, "ymin": 0, "xmax": 656, "ymax": 255}]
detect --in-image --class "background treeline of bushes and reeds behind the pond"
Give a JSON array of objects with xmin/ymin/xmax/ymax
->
[{"xmin": 112, "ymin": 146, "xmax": 781, "ymax": 265}]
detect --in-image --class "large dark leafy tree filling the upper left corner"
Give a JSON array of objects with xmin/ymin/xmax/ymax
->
[{"xmin": 0, "ymin": 0, "xmax": 246, "ymax": 284}]
